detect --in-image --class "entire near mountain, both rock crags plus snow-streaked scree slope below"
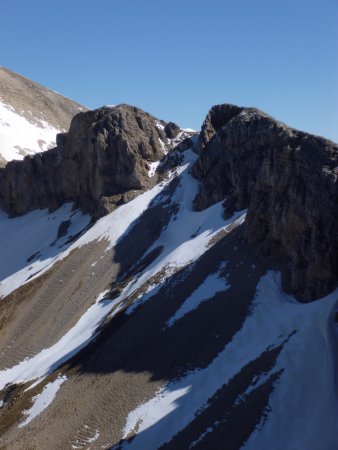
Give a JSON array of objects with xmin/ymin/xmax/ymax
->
[{"xmin": 0, "ymin": 72, "xmax": 338, "ymax": 450}]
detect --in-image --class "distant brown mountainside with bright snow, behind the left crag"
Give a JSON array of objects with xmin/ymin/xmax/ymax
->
[{"xmin": 0, "ymin": 67, "xmax": 86, "ymax": 165}]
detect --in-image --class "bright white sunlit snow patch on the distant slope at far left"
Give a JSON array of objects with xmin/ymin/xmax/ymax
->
[{"xmin": 0, "ymin": 99, "xmax": 62, "ymax": 161}]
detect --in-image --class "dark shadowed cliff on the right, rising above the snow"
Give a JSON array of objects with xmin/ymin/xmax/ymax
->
[{"xmin": 192, "ymin": 105, "xmax": 338, "ymax": 300}]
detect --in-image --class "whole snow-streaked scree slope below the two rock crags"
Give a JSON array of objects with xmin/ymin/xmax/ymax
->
[{"xmin": 0, "ymin": 145, "xmax": 338, "ymax": 450}]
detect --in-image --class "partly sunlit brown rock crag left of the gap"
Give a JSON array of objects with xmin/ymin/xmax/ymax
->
[{"xmin": 0, "ymin": 105, "xmax": 180, "ymax": 216}]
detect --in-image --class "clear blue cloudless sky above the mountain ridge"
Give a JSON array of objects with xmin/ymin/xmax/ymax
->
[{"xmin": 0, "ymin": 0, "xmax": 338, "ymax": 141}]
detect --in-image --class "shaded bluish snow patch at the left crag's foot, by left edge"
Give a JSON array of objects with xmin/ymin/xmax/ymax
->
[{"xmin": 0, "ymin": 203, "xmax": 90, "ymax": 299}]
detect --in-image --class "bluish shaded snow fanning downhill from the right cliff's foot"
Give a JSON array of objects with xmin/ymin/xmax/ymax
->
[{"xmin": 119, "ymin": 272, "xmax": 338, "ymax": 450}]
